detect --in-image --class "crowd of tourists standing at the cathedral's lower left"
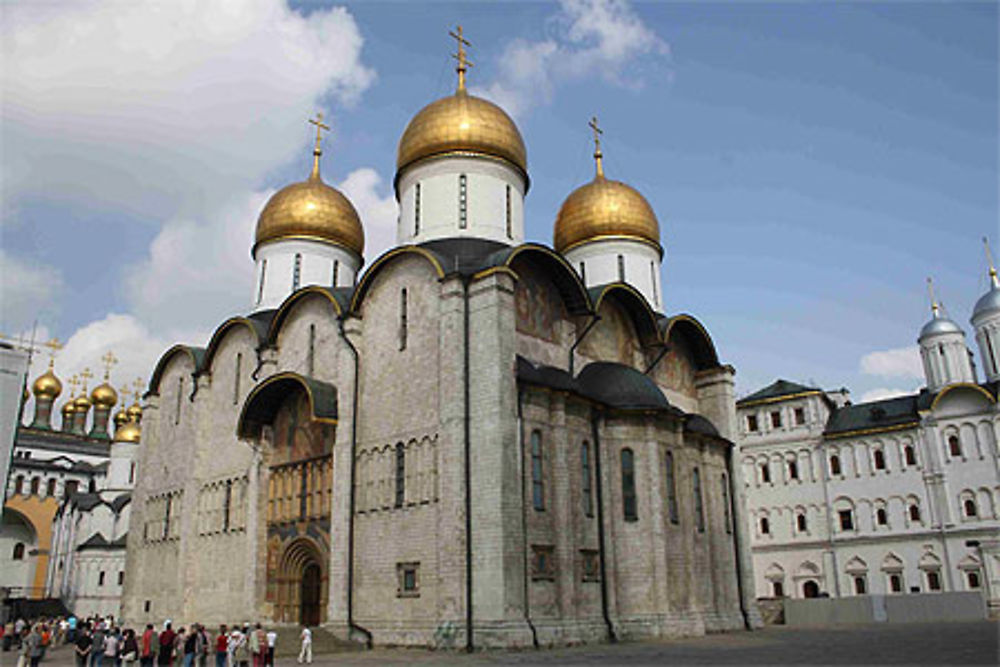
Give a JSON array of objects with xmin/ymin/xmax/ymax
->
[{"xmin": 0, "ymin": 616, "xmax": 288, "ymax": 667}]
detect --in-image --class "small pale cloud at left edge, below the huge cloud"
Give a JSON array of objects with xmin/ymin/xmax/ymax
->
[{"xmin": 0, "ymin": 248, "xmax": 64, "ymax": 335}]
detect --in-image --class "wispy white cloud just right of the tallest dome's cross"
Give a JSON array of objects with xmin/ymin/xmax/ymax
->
[{"xmin": 476, "ymin": 0, "xmax": 670, "ymax": 116}]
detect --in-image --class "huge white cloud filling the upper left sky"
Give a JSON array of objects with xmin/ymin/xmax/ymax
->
[{"xmin": 0, "ymin": 0, "xmax": 375, "ymax": 222}]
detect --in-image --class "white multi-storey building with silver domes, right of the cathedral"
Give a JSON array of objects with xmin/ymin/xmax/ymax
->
[{"xmin": 737, "ymin": 268, "xmax": 1000, "ymax": 620}]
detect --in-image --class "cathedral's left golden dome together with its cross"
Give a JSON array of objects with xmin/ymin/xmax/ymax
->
[{"xmin": 253, "ymin": 121, "xmax": 365, "ymax": 255}]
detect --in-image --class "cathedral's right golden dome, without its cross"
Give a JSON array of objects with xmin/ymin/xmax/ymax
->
[{"xmin": 553, "ymin": 174, "xmax": 663, "ymax": 253}]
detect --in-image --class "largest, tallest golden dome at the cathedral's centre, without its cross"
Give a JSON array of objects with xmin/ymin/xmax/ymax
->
[{"xmin": 396, "ymin": 91, "xmax": 528, "ymax": 178}]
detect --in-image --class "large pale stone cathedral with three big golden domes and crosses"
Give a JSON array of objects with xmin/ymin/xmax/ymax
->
[{"xmin": 122, "ymin": 28, "xmax": 760, "ymax": 649}]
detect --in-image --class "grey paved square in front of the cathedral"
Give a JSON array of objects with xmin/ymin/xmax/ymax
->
[{"xmin": 17, "ymin": 621, "xmax": 1000, "ymax": 667}]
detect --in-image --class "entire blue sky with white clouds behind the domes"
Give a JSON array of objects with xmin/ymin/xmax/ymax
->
[{"xmin": 0, "ymin": 2, "xmax": 1000, "ymax": 400}]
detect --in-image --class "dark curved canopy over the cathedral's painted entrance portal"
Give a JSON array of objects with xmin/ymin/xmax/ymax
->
[{"xmin": 236, "ymin": 372, "xmax": 337, "ymax": 438}]
